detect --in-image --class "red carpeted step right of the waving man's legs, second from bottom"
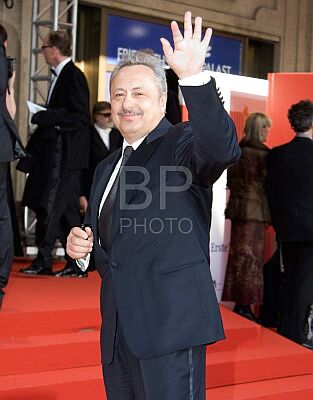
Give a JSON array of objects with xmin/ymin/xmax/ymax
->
[{"xmin": 207, "ymin": 318, "xmax": 313, "ymax": 387}]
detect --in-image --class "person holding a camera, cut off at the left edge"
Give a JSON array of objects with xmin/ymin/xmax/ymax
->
[{"xmin": 0, "ymin": 25, "xmax": 25, "ymax": 308}]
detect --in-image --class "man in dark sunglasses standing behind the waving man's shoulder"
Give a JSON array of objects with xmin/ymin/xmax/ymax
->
[{"xmin": 80, "ymin": 101, "xmax": 123, "ymax": 211}]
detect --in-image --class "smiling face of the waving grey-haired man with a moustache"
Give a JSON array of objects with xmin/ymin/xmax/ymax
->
[{"xmin": 111, "ymin": 65, "xmax": 166, "ymax": 144}]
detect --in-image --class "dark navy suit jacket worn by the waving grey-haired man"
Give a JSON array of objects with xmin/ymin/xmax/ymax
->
[{"xmin": 85, "ymin": 81, "xmax": 240, "ymax": 362}]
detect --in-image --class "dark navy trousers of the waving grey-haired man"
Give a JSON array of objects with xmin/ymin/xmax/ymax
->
[{"xmin": 103, "ymin": 327, "xmax": 206, "ymax": 400}]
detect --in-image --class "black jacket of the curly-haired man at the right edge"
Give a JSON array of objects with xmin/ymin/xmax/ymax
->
[{"xmin": 267, "ymin": 137, "xmax": 313, "ymax": 241}]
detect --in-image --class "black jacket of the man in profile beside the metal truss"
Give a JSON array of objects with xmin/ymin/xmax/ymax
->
[{"xmin": 17, "ymin": 61, "xmax": 90, "ymax": 209}]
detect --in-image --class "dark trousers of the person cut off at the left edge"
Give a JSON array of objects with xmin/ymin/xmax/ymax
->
[{"xmin": 0, "ymin": 162, "xmax": 14, "ymax": 290}]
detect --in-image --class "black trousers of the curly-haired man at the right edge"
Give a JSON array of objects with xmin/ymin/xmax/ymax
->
[{"xmin": 278, "ymin": 242, "xmax": 313, "ymax": 343}]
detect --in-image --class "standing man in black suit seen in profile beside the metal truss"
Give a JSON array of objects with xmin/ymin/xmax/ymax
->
[{"xmin": 21, "ymin": 31, "xmax": 90, "ymax": 276}]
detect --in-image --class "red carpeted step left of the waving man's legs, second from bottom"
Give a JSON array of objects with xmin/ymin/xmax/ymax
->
[{"xmin": 0, "ymin": 331, "xmax": 100, "ymax": 376}]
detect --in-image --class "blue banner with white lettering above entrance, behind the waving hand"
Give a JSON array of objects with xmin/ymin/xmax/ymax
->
[{"xmin": 106, "ymin": 15, "xmax": 242, "ymax": 75}]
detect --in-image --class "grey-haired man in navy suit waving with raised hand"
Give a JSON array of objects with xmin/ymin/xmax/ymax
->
[{"xmin": 67, "ymin": 12, "xmax": 240, "ymax": 400}]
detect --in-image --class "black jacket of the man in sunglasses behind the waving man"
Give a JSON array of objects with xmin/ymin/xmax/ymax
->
[{"xmin": 81, "ymin": 125, "xmax": 123, "ymax": 199}]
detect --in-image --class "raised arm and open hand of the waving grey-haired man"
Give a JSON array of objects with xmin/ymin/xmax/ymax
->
[{"xmin": 161, "ymin": 11, "xmax": 240, "ymax": 186}]
